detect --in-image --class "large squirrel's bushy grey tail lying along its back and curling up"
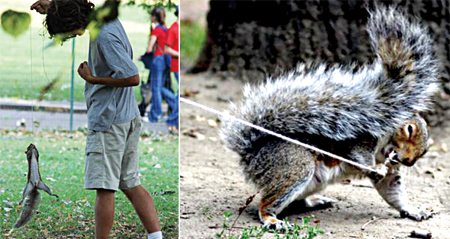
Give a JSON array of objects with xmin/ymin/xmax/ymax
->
[{"xmin": 221, "ymin": 7, "xmax": 440, "ymax": 158}]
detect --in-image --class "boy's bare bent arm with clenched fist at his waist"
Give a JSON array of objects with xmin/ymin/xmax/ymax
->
[{"xmin": 78, "ymin": 62, "xmax": 140, "ymax": 87}]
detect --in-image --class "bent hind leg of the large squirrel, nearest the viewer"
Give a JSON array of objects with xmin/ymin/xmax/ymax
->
[{"xmin": 250, "ymin": 142, "xmax": 315, "ymax": 230}]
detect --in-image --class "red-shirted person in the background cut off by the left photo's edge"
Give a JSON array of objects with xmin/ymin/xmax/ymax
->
[{"xmin": 165, "ymin": 6, "xmax": 180, "ymax": 134}]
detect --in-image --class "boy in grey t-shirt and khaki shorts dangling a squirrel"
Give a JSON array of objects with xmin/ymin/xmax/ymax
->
[{"xmin": 31, "ymin": 0, "xmax": 162, "ymax": 239}]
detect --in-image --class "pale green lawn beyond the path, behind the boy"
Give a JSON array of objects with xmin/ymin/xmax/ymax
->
[{"xmin": 0, "ymin": 0, "xmax": 176, "ymax": 101}]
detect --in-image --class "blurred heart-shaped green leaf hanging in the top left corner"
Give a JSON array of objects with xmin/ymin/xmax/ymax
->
[{"xmin": 1, "ymin": 10, "xmax": 31, "ymax": 38}]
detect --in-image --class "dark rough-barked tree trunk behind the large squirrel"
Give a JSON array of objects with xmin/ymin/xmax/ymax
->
[{"xmin": 190, "ymin": 0, "xmax": 450, "ymax": 125}]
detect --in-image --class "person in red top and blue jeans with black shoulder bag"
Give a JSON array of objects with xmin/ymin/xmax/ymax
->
[{"xmin": 147, "ymin": 8, "xmax": 178, "ymax": 132}]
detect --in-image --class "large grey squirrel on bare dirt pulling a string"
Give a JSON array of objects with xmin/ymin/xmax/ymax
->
[{"xmin": 221, "ymin": 7, "xmax": 439, "ymax": 228}]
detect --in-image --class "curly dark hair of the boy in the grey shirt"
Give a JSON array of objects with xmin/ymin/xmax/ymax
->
[{"xmin": 44, "ymin": 0, "xmax": 94, "ymax": 38}]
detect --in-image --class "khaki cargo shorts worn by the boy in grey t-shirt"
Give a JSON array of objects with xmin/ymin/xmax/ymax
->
[{"xmin": 84, "ymin": 117, "xmax": 141, "ymax": 191}]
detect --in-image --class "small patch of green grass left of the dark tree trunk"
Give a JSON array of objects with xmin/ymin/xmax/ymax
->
[{"xmin": 180, "ymin": 22, "xmax": 206, "ymax": 68}]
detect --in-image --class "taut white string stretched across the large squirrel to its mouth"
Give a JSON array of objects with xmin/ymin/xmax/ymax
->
[{"xmin": 180, "ymin": 97, "xmax": 378, "ymax": 174}]
